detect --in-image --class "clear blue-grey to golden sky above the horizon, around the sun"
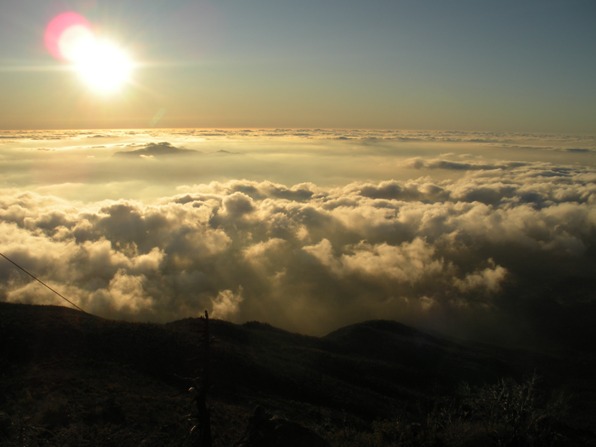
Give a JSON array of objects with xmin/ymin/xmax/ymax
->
[{"xmin": 0, "ymin": 0, "xmax": 596, "ymax": 134}]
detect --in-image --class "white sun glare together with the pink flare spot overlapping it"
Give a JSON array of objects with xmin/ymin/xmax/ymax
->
[{"xmin": 45, "ymin": 12, "xmax": 133, "ymax": 94}]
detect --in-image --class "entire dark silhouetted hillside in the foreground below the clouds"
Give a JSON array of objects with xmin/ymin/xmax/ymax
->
[{"xmin": 0, "ymin": 303, "xmax": 596, "ymax": 446}]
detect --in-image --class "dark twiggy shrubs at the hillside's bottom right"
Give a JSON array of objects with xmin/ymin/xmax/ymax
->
[{"xmin": 330, "ymin": 374, "xmax": 588, "ymax": 447}]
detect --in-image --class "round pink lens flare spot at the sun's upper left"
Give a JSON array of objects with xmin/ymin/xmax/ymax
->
[{"xmin": 44, "ymin": 11, "xmax": 93, "ymax": 61}]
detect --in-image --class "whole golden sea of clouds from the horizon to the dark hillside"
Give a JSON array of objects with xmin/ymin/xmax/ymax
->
[{"xmin": 0, "ymin": 129, "xmax": 596, "ymax": 344}]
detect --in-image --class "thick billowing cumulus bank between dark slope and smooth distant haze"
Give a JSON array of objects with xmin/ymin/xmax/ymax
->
[{"xmin": 0, "ymin": 132, "xmax": 596, "ymax": 348}]
